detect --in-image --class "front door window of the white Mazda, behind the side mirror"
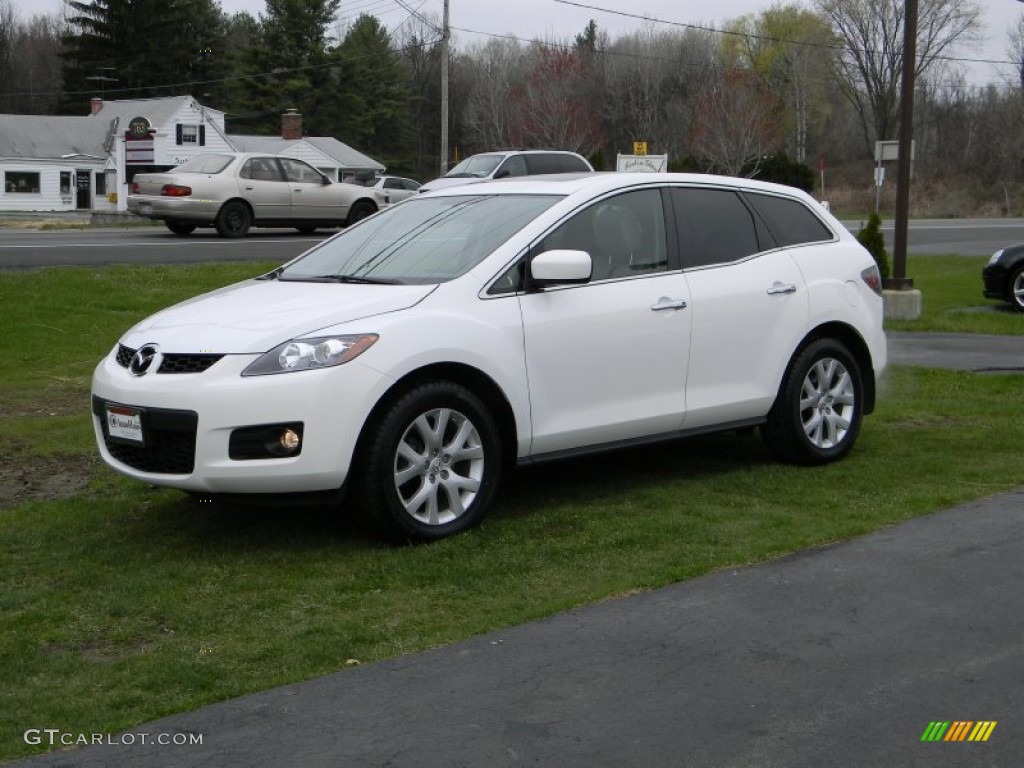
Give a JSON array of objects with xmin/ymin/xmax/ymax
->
[{"xmin": 538, "ymin": 189, "xmax": 668, "ymax": 281}]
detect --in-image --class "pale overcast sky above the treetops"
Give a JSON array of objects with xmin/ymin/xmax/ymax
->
[{"xmin": 14, "ymin": 0, "xmax": 1024, "ymax": 85}]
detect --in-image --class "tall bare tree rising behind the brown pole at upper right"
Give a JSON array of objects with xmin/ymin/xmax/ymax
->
[{"xmin": 814, "ymin": 0, "xmax": 982, "ymax": 151}]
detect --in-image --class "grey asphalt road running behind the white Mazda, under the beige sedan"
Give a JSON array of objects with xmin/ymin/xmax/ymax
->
[{"xmin": 0, "ymin": 219, "xmax": 1024, "ymax": 268}]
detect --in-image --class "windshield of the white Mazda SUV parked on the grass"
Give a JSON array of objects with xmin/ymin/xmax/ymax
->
[{"xmin": 279, "ymin": 195, "xmax": 560, "ymax": 284}]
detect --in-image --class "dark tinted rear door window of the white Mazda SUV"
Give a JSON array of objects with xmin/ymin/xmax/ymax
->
[{"xmin": 672, "ymin": 188, "xmax": 761, "ymax": 268}]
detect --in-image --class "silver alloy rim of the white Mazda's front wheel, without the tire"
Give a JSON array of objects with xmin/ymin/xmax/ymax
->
[{"xmin": 394, "ymin": 408, "xmax": 484, "ymax": 525}]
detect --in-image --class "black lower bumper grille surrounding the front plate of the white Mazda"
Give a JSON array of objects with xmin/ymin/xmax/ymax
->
[{"xmin": 92, "ymin": 396, "xmax": 199, "ymax": 475}]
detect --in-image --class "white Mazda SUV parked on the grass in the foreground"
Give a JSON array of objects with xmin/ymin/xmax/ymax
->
[{"xmin": 92, "ymin": 174, "xmax": 886, "ymax": 540}]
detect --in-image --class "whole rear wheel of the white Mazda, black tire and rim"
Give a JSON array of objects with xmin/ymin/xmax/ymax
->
[{"xmin": 762, "ymin": 339, "xmax": 864, "ymax": 464}]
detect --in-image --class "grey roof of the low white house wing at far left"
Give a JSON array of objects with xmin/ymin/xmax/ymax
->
[{"xmin": 0, "ymin": 115, "xmax": 110, "ymax": 160}]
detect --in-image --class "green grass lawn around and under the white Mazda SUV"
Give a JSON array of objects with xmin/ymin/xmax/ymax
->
[{"xmin": 0, "ymin": 257, "xmax": 1024, "ymax": 759}]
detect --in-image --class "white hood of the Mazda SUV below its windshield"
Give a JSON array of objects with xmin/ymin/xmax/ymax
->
[{"xmin": 121, "ymin": 280, "xmax": 436, "ymax": 354}]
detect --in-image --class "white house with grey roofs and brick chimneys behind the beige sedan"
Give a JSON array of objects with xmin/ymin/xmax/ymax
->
[{"xmin": 0, "ymin": 96, "xmax": 384, "ymax": 217}]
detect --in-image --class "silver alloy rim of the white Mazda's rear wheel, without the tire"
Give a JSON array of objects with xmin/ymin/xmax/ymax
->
[{"xmin": 800, "ymin": 357, "xmax": 857, "ymax": 449}]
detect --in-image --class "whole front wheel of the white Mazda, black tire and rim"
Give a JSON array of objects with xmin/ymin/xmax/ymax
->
[{"xmin": 353, "ymin": 381, "xmax": 502, "ymax": 543}]
